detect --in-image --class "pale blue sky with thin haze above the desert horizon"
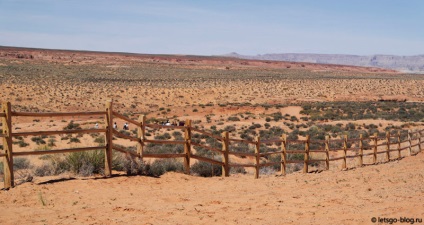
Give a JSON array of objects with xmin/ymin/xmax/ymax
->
[{"xmin": 0, "ymin": 0, "xmax": 424, "ymax": 55}]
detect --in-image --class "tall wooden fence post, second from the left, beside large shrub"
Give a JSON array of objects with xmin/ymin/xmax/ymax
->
[{"xmin": 105, "ymin": 100, "xmax": 113, "ymax": 177}]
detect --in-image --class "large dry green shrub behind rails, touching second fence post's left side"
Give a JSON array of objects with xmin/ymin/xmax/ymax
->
[{"xmin": 65, "ymin": 150, "xmax": 105, "ymax": 176}]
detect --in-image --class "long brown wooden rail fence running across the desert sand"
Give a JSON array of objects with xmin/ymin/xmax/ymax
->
[{"xmin": 0, "ymin": 101, "xmax": 424, "ymax": 189}]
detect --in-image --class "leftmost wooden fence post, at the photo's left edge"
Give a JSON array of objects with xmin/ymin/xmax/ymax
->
[{"xmin": 2, "ymin": 102, "xmax": 15, "ymax": 189}]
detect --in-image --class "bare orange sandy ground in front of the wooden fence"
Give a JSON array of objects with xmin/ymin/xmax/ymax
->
[{"xmin": 0, "ymin": 153, "xmax": 424, "ymax": 224}]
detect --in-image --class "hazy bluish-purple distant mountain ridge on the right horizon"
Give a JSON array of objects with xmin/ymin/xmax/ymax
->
[{"xmin": 225, "ymin": 52, "xmax": 424, "ymax": 73}]
